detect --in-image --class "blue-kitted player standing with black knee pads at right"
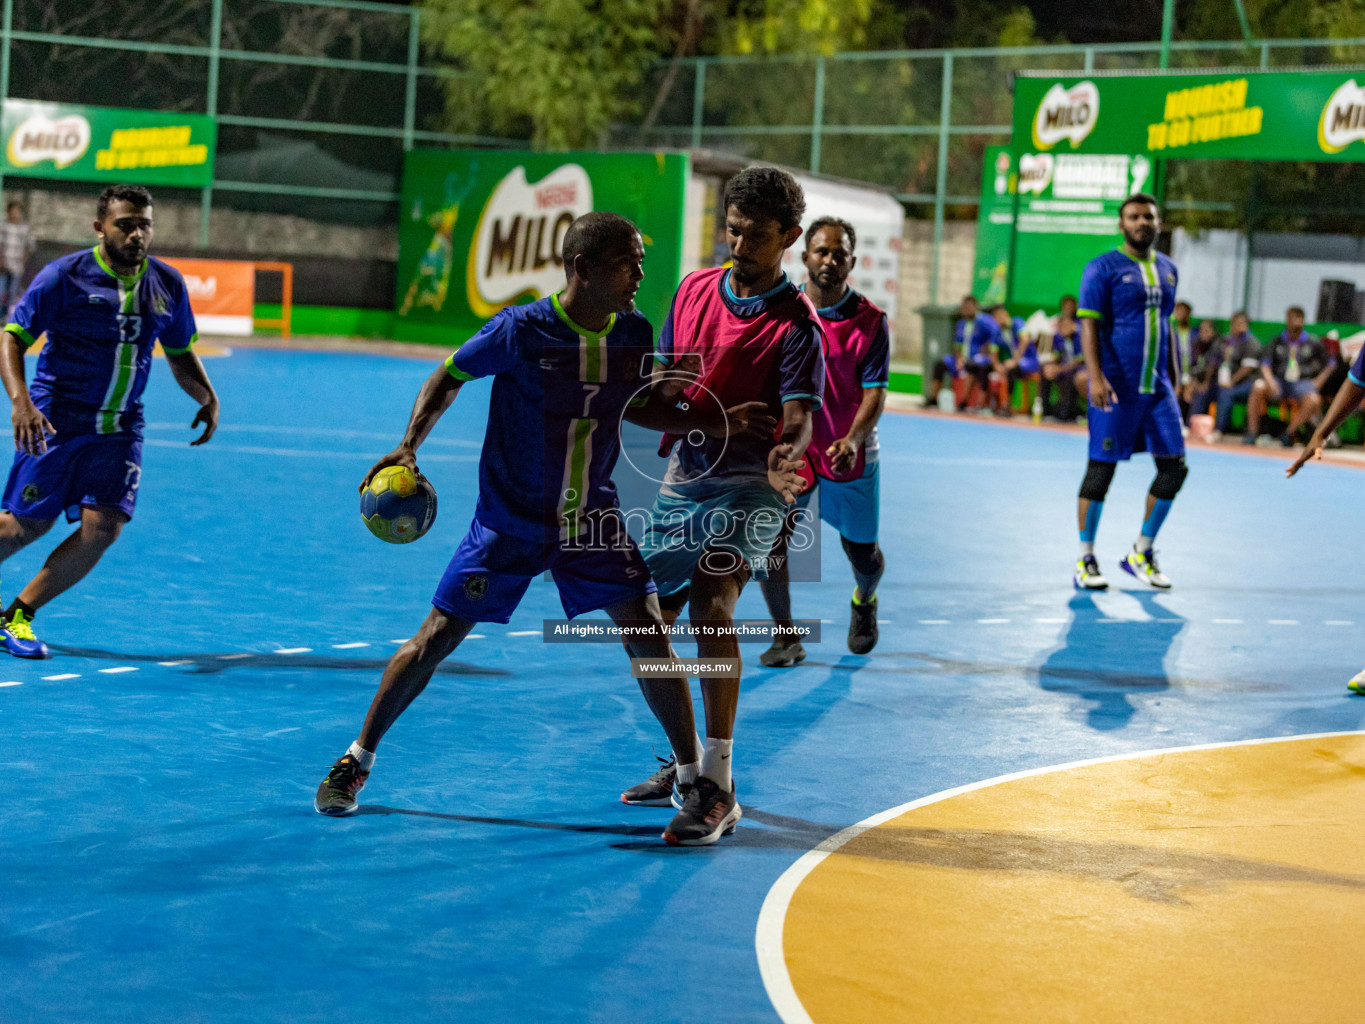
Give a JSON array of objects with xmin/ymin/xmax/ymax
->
[{"xmin": 1073, "ymin": 193, "xmax": 1189, "ymax": 590}]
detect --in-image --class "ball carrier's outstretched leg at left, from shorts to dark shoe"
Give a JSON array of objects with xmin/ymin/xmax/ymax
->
[{"xmin": 313, "ymin": 608, "xmax": 474, "ymax": 816}]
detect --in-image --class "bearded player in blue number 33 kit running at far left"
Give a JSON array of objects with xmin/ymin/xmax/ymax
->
[{"xmin": 0, "ymin": 186, "xmax": 218, "ymax": 658}]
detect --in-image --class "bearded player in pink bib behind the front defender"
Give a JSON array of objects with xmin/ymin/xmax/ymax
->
[{"xmin": 759, "ymin": 217, "xmax": 891, "ymax": 668}]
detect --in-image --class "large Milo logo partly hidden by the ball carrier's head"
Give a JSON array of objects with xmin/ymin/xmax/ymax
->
[{"xmin": 465, "ymin": 164, "xmax": 592, "ymax": 317}]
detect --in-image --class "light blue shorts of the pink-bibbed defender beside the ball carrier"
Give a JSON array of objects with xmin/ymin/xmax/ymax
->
[{"xmin": 640, "ymin": 477, "xmax": 788, "ymax": 595}]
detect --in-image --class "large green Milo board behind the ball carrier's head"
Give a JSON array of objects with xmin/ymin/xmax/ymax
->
[{"xmin": 396, "ymin": 150, "xmax": 688, "ymax": 347}]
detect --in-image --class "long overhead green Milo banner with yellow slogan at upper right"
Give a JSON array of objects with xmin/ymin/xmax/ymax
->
[{"xmin": 1013, "ymin": 70, "xmax": 1365, "ymax": 161}]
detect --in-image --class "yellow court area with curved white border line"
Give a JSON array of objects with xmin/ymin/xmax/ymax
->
[{"xmin": 758, "ymin": 733, "xmax": 1365, "ymax": 1024}]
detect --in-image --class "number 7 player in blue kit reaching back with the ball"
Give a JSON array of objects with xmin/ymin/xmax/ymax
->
[{"xmin": 314, "ymin": 213, "xmax": 777, "ymax": 815}]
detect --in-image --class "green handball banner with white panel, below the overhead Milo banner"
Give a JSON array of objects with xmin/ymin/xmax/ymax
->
[{"xmin": 972, "ymin": 146, "xmax": 1152, "ymax": 313}]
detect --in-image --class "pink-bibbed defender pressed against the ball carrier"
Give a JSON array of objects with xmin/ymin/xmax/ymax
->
[{"xmin": 621, "ymin": 167, "xmax": 824, "ymax": 845}]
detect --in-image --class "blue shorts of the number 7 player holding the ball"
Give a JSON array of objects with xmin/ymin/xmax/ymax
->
[{"xmin": 431, "ymin": 515, "xmax": 655, "ymax": 623}]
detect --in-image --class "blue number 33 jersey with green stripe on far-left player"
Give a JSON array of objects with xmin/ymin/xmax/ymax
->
[{"xmin": 5, "ymin": 248, "xmax": 198, "ymax": 437}]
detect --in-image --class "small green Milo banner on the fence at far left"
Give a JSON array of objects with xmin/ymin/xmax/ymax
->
[{"xmin": 0, "ymin": 100, "xmax": 218, "ymax": 188}]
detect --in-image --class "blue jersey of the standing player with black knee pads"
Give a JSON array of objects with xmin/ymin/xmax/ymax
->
[{"xmin": 1078, "ymin": 248, "xmax": 1179, "ymax": 400}]
